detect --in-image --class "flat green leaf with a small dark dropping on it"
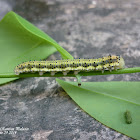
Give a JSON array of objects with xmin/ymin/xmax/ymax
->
[{"xmin": 57, "ymin": 79, "xmax": 140, "ymax": 139}]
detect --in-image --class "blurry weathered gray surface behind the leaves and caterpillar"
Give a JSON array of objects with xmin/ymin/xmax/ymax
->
[{"xmin": 0, "ymin": 0, "xmax": 140, "ymax": 140}]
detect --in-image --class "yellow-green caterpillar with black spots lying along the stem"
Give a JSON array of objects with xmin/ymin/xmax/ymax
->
[{"xmin": 14, "ymin": 55, "xmax": 125, "ymax": 76}]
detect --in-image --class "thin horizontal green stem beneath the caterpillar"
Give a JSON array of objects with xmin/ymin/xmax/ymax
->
[{"xmin": 0, "ymin": 67, "xmax": 140, "ymax": 78}]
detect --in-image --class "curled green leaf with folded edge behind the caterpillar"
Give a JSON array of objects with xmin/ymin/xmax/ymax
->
[{"xmin": 0, "ymin": 12, "xmax": 73, "ymax": 84}]
